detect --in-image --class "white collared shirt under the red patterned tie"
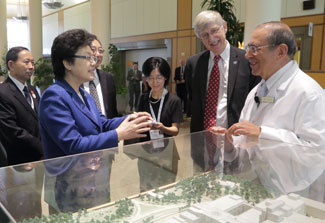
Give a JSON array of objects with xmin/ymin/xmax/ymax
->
[{"xmin": 206, "ymin": 42, "xmax": 230, "ymax": 128}]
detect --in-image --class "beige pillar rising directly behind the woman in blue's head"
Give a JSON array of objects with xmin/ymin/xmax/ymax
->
[{"xmin": 90, "ymin": 0, "xmax": 111, "ymax": 65}]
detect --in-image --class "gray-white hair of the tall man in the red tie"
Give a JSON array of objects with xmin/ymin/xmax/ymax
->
[{"xmin": 194, "ymin": 10, "xmax": 224, "ymax": 38}]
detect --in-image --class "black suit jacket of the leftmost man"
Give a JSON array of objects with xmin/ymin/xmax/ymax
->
[{"xmin": 0, "ymin": 78, "xmax": 43, "ymax": 165}]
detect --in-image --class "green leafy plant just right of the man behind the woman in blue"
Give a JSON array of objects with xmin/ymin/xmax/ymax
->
[{"xmin": 101, "ymin": 44, "xmax": 128, "ymax": 113}]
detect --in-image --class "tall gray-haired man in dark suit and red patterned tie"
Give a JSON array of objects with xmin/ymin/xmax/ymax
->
[{"xmin": 185, "ymin": 10, "xmax": 260, "ymax": 132}]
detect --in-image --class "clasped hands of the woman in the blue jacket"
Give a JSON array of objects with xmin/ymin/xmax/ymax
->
[{"xmin": 116, "ymin": 112, "xmax": 152, "ymax": 140}]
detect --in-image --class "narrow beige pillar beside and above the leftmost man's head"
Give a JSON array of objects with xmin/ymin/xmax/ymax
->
[{"xmin": 29, "ymin": 0, "xmax": 43, "ymax": 61}]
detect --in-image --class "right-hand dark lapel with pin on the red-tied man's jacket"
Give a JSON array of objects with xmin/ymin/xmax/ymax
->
[{"xmin": 227, "ymin": 46, "xmax": 240, "ymax": 105}]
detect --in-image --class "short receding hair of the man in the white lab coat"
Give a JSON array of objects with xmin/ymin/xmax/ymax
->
[{"xmin": 258, "ymin": 21, "xmax": 297, "ymax": 59}]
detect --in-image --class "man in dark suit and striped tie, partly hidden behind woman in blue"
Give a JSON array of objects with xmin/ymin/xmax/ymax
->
[{"xmin": 84, "ymin": 35, "xmax": 118, "ymax": 119}]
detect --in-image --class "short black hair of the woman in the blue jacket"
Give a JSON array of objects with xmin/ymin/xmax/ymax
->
[{"xmin": 51, "ymin": 29, "xmax": 92, "ymax": 79}]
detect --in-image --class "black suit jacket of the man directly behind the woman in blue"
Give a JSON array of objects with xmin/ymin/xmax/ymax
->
[{"xmin": 97, "ymin": 69, "xmax": 117, "ymax": 118}]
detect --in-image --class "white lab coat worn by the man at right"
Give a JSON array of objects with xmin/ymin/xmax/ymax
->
[{"xmin": 239, "ymin": 61, "xmax": 325, "ymax": 146}]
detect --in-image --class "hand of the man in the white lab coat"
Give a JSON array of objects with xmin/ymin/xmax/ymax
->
[{"xmin": 227, "ymin": 121, "xmax": 261, "ymax": 137}]
